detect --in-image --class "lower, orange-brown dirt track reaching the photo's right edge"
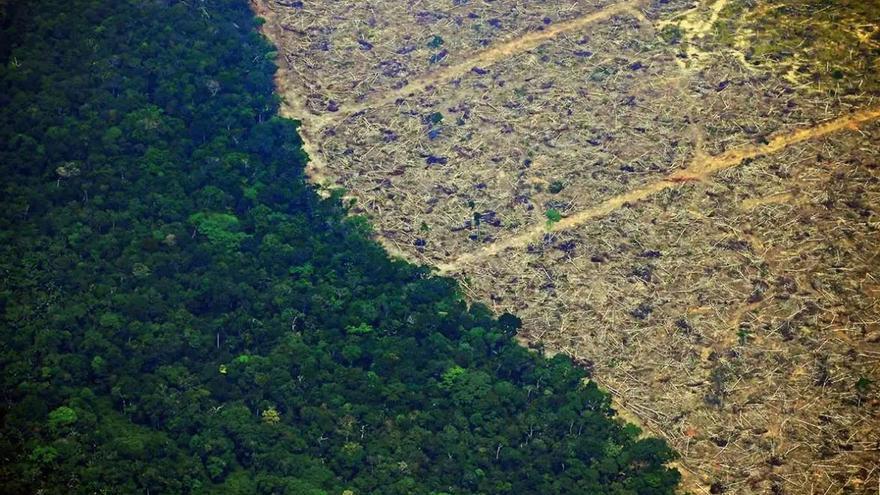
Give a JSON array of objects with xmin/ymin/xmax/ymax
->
[{"xmin": 437, "ymin": 107, "xmax": 880, "ymax": 274}]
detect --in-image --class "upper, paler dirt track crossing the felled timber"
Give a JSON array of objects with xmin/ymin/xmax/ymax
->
[{"xmin": 316, "ymin": 0, "xmax": 643, "ymax": 127}]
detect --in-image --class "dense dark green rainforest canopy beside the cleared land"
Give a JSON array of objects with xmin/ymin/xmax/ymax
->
[{"xmin": 0, "ymin": 0, "xmax": 679, "ymax": 495}]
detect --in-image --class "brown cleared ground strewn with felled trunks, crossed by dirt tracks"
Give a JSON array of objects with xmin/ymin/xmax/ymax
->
[{"xmin": 255, "ymin": 0, "xmax": 880, "ymax": 494}]
